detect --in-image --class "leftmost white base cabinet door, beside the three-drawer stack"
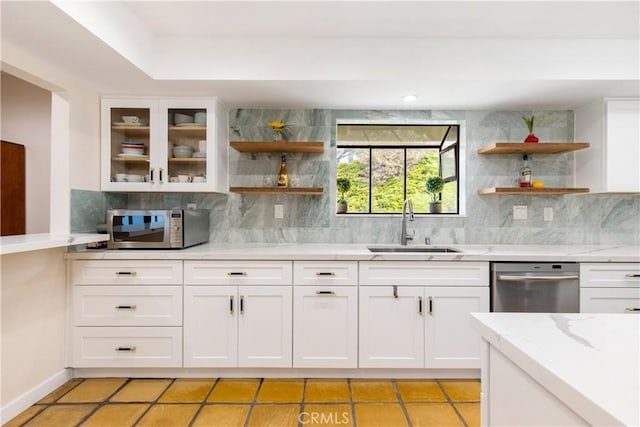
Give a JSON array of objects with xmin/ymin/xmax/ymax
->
[{"xmin": 184, "ymin": 286, "xmax": 238, "ymax": 368}]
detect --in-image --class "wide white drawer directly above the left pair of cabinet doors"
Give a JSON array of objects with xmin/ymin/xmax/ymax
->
[{"xmin": 184, "ymin": 261, "xmax": 293, "ymax": 285}]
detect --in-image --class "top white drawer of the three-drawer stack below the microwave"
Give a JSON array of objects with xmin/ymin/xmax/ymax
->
[{"xmin": 71, "ymin": 260, "xmax": 182, "ymax": 285}]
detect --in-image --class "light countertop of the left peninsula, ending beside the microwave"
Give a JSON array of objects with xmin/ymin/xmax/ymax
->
[{"xmin": 0, "ymin": 233, "xmax": 109, "ymax": 255}]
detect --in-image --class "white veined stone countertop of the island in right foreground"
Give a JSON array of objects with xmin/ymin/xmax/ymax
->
[{"xmin": 471, "ymin": 313, "xmax": 640, "ymax": 426}]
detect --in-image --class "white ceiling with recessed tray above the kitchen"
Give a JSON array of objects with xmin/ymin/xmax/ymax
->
[{"xmin": 0, "ymin": 0, "xmax": 640, "ymax": 110}]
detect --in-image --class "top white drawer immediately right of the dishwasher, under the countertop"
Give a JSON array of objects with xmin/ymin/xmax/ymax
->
[{"xmin": 580, "ymin": 262, "xmax": 640, "ymax": 288}]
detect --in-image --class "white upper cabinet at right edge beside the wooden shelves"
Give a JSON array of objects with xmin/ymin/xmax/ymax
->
[{"xmin": 574, "ymin": 98, "xmax": 640, "ymax": 193}]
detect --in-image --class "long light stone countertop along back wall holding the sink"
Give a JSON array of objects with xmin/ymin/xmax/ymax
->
[{"xmin": 66, "ymin": 243, "xmax": 640, "ymax": 262}]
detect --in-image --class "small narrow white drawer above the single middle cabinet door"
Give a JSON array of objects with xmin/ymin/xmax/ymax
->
[{"xmin": 293, "ymin": 261, "xmax": 358, "ymax": 286}]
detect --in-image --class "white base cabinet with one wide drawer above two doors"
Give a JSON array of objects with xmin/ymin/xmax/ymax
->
[{"xmin": 184, "ymin": 261, "xmax": 292, "ymax": 367}]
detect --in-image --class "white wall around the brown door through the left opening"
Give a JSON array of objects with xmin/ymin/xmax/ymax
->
[{"xmin": 0, "ymin": 72, "xmax": 51, "ymax": 233}]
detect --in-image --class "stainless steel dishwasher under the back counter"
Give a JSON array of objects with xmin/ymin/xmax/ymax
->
[{"xmin": 491, "ymin": 262, "xmax": 580, "ymax": 313}]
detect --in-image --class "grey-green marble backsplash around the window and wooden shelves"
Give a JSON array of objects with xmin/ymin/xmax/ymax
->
[{"xmin": 71, "ymin": 109, "xmax": 640, "ymax": 245}]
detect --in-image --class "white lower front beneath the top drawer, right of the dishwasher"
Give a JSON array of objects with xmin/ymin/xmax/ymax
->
[{"xmin": 580, "ymin": 288, "xmax": 640, "ymax": 315}]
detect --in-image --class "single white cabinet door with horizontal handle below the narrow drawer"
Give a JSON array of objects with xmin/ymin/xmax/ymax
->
[{"xmin": 293, "ymin": 286, "xmax": 358, "ymax": 368}]
